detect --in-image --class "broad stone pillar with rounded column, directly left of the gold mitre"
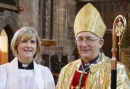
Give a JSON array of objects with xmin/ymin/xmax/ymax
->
[{"xmin": 55, "ymin": 0, "xmax": 76, "ymax": 62}]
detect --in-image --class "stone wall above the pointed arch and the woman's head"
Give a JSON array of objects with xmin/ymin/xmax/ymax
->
[{"xmin": 0, "ymin": 0, "xmax": 39, "ymax": 30}]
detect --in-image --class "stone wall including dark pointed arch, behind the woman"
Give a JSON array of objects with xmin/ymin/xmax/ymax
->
[{"xmin": 0, "ymin": 0, "xmax": 39, "ymax": 61}]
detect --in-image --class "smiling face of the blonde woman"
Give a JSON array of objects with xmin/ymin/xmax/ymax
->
[{"xmin": 17, "ymin": 37, "xmax": 37, "ymax": 63}]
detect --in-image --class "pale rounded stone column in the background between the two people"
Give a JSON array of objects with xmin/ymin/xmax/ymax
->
[{"xmin": 56, "ymin": 0, "xmax": 67, "ymax": 46}]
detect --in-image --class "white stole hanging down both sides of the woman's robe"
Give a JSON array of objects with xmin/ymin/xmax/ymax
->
[{"xmin": 7, "ymin": 57, "xmax": 44, "ymax": 89}]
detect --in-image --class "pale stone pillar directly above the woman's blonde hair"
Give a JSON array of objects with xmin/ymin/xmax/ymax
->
[{"xmin": 18, "ymin": 0, "xmax": 39, "ymax": 30}]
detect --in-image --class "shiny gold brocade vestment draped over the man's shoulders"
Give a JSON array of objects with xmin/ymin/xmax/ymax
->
[{"xmin": 56, "ymin": 53, "xmax": 130, "ymax": 89}]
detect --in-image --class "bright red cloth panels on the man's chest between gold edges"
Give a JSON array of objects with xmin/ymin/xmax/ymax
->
[{"xmin": 70, "ymin": 70, "xmax": 88, "ymax": 89}]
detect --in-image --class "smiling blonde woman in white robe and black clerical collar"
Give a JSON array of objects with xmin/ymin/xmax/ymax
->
[{"xmin": 0, "ymin": 27, "xmax": 55, "ymax": 89}]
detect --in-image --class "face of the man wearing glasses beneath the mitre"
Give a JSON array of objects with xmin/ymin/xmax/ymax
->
[{"xmin": 76, "ymin": 32, "xmax": 104, "ymax": 63}]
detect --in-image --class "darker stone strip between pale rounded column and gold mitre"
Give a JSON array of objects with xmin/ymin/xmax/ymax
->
[{"xmin": 63, "ymin": 0, "xmax": 76, "ymax": 62}]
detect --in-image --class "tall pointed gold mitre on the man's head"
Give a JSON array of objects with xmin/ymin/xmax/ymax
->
[{"xmin": 74, "ymin": 3, "xmax": 106, "ymax": 38}]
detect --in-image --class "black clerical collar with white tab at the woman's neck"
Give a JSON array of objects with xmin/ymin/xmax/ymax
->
[{"xmin": 18, "ymin": 60, "xmax": 34, "ymax": 70}]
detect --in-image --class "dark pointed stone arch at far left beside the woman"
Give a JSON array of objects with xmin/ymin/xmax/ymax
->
[{"xmin": 0, "ymin": 15, "xmax": 19, "ymax": 62}]
